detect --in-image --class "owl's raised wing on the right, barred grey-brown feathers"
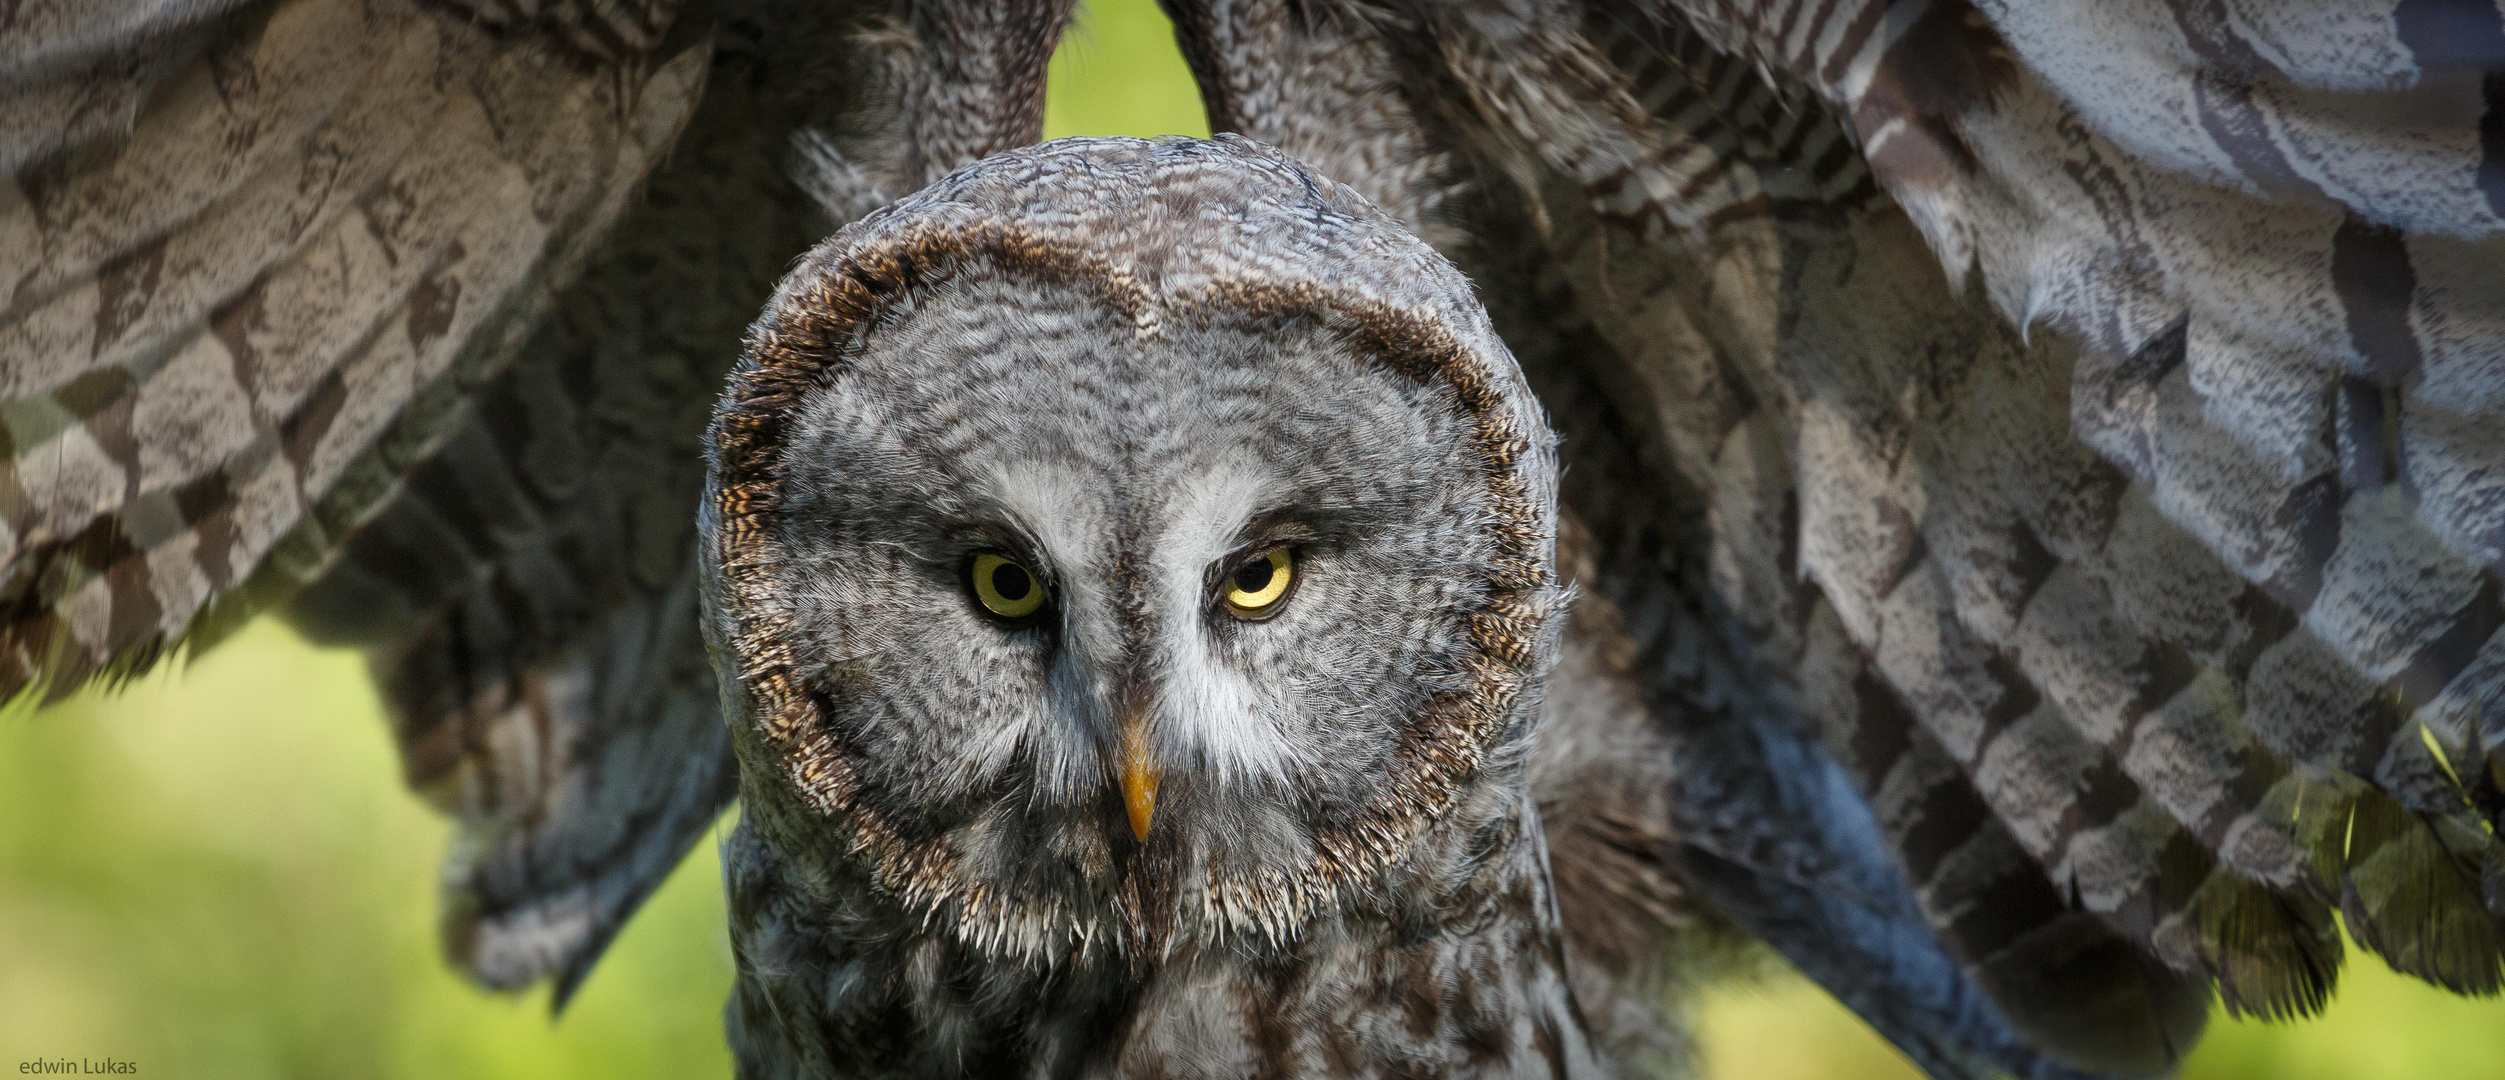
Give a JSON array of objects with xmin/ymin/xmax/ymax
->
[{"xmin": 1177, "ymin": 0, "xmax": 2505, "ymax": 1075}]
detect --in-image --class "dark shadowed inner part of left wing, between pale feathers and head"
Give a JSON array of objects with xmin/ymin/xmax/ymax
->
[{"xmin": 284, "ymin": 5, "xmax": 1067, "ymax": 1007}]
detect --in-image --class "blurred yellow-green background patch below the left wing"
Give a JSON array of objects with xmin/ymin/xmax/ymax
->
[{"xmin": 0, "ymin": 621, "xmax": 731, "ymax": 1080}]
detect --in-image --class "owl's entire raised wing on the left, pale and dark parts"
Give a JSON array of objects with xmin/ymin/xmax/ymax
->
[{"xmin": 0, "ymin": 0, "xmax": 1067, "ymax": 1002}]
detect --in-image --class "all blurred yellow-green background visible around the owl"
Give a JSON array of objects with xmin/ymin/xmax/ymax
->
[{"xmin": 0, "ymin": 0, "xmax": 2505, "ymax": 1080}]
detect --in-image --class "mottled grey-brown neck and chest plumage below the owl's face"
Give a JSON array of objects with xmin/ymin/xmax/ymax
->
[{"xmin": 726, "ymin": 769, "xmax": 1593, "ymax": 1077}]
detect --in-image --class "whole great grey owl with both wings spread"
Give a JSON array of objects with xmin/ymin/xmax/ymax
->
[{"xmin": 14, "ymin": 0, "xmax": 2505, "ymax": 1077}]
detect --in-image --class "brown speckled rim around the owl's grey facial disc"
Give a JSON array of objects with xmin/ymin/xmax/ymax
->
[{"xmin": 711, "ymin": 221, "xmax": 1556, "ymax": 942}]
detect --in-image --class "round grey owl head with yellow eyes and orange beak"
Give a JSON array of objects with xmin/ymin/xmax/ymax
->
[{"xmin": 701, "ymin": 138, "xmax": 1558, "ymax": 962}]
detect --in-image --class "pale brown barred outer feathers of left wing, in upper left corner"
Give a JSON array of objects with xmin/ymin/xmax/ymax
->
[{"xmin": 0, "ymin": 0, "xmax": 709, "ymax": 694}]
